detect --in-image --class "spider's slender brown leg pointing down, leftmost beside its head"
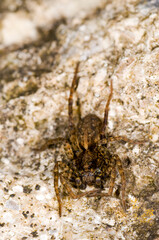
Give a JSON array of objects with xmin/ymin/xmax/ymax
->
[{"xmin": 53, "ymin": 162, "xmax": 62, "ymax": 217}]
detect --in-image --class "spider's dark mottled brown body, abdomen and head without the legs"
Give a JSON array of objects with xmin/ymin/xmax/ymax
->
[{"xmin": 67, "ymin": 114, "xmax": 111, "ymax": 189}]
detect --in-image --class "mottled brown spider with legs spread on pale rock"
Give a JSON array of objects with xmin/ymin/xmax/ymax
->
[{"xmin": 51, "ymin": 62, "xmax": 126, "ymax": 216}]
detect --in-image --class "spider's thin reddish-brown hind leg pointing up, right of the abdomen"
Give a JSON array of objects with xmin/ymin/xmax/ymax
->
[{"xmin": 101, "ymin": 80, "xmax": 113, "ymax": 138}]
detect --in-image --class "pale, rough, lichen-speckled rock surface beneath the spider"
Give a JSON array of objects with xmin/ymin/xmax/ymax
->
[{"xmin": 0, "ymin": 0, "xmax": 159, "ymax": 240}]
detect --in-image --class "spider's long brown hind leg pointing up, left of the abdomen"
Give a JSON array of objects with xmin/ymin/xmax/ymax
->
[{"xmin": 68, "ymin": 62, "xmax": 79, "ymax": 127}]
